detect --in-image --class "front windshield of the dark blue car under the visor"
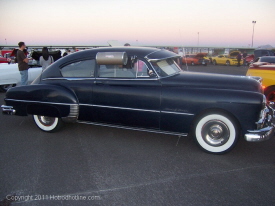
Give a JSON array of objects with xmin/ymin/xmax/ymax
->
[{"xmin": 151, "ymin": 59, "xmax": 180, "ymax": 77}]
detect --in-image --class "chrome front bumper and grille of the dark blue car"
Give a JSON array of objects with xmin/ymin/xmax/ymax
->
[{"xmin": 244, "ymin": 104, "xmax": 275, "ymax": 142}]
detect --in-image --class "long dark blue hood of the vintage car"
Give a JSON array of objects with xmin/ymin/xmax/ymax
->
[{"xmin": 161, "ymin": 72, "xmax": 262, "ymax": 92}]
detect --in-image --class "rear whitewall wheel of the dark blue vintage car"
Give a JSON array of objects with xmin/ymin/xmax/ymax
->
[{"xmin": 33, "ymin": 115, "xmax": 63, "ymax": 132}]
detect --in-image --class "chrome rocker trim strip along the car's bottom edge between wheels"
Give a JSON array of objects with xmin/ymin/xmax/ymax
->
[{"xmin": 77, "ymin": 121, "xmax": 188, "ymax": 136}]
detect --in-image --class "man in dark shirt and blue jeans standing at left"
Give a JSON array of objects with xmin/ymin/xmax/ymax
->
[{"xmin": 16, "ymin": 42, "xmax": 29, "ymax": 86}]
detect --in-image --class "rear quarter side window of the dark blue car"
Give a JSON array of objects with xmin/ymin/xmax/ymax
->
[{"xmin": 61, "ymin": 59, "xmax": 95, "ymax": 77}]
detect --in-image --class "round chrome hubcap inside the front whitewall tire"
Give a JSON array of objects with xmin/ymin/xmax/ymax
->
[{"xmin": 201, "ymin": 120, "xmax": 230, "ymax": 147}]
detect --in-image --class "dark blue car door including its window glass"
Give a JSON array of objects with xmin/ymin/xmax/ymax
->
[{"xmin": 93, "ymin": 60, "xmax": 161, "ymax": 129}]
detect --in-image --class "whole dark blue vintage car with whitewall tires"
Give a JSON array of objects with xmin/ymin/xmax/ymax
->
[{"xmin": 2, "ymin": 47, "xmax": 274, "ymax": 154}]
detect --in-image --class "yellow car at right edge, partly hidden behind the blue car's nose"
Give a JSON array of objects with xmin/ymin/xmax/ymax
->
[{"xmin": 246, "ymin": 62, "xmax": 275, "ymax": 102}]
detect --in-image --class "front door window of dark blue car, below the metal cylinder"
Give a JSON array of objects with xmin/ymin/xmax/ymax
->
[{"xmin": 98, "ymin": 60, "xmax": 149, "ymax": 79}]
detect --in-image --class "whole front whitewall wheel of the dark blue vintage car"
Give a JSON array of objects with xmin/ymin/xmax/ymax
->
[{"xmin": 195, "ymin": 113, "xmax": 239, "ymax": 154}]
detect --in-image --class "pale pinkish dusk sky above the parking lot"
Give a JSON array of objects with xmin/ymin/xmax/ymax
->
[{"xmin": 0, "ymin": 0, "xmax": 275, "ymax": 47}]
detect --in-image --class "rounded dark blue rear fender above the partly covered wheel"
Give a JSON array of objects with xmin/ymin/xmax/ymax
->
[{"xmin": 5, "ymin": 84, "xmax": 79, "ymax": 121}]
